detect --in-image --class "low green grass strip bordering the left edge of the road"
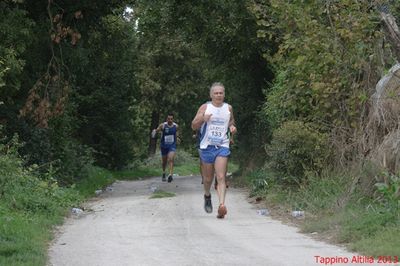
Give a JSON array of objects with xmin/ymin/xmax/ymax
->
[{"xmin": 0, "ymin": 163, "xmax": 115, "ymax": 266}]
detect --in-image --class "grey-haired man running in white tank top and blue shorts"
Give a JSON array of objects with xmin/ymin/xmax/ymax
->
[{"xmin": 192, "ymin": 83, "xmax": 236, "ymax": 218}]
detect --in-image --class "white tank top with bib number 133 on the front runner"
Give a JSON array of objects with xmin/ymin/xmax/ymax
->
[{"xmin": 200, "ymin": 103, "xmax": 231, "ymax": 149}]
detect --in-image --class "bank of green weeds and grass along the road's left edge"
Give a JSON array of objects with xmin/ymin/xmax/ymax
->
[{"xmin": 0, "ymin": 132, "xmax": 113, "ymax": 265}]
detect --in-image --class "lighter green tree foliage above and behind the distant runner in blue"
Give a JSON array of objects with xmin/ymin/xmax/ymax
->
[{"xmin": 135, "ymin": 1, "xmax": 208, "ymax": 149}]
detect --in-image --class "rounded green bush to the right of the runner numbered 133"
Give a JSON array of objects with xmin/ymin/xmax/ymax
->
[{"xmin": 267, "ymin": 121, "xmax": 329, "ymax": 184}]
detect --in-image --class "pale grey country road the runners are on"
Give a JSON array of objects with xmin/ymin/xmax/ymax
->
[{"xmin": 49, "ymin": 176, "xmax": 372, "ymax": 266}]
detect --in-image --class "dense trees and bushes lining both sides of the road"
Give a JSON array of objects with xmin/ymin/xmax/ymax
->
[{"xmin": 0, "ymin": 0, "xmax": 400, "ymax": 262}]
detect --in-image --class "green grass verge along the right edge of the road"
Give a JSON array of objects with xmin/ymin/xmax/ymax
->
[{"xmin": 243, "ymin": 167, "xmax": 400, "ymax": 256}]
